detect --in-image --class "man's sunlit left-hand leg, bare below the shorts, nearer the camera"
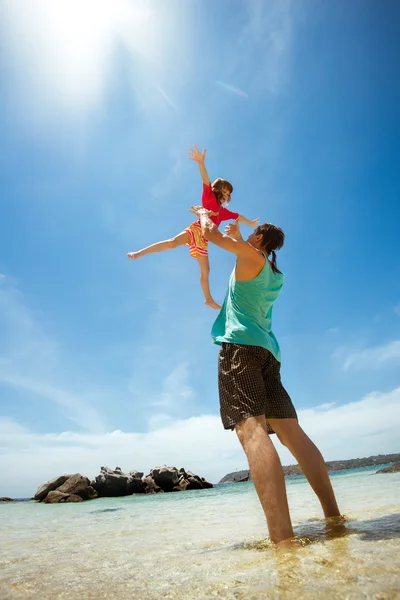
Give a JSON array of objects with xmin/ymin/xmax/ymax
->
[{"xmin": 235, "ymin": 416, "xmax": 293, "ymax": 544}]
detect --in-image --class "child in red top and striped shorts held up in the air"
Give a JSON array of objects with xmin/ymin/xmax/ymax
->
[{"xmin": 127, "ymin": 146, "xmax": 259, "ymax": 310}]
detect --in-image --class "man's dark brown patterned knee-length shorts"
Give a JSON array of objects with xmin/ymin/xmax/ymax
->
[{"xmin": 218, "ymin": 342, "xmax": 297, "ymax": 433}]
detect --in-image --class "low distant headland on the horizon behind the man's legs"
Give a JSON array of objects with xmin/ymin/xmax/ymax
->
[{"xmin": 219, "ymin": 454, "xmax": 400, "ymax": 483}]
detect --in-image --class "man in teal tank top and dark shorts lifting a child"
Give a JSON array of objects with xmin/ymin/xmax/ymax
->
[{"xmin": 192, "ymin": 207, "xmax": 340, "ymax": 546}]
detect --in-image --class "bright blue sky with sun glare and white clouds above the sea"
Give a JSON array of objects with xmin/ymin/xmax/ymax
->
[{"xmin": 0, "ymin": 0, "xmax": 400, "ymax": 495}]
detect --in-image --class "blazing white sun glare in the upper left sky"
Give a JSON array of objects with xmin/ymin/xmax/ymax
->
[{"xmin": 7, "ymin": 0, "xmax": 160, "ymax": 110}]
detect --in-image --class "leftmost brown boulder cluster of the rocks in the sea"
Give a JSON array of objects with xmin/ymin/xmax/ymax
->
[{"xmin": 34, "ymin": 473, "xmax": 97, "ymax": 504}]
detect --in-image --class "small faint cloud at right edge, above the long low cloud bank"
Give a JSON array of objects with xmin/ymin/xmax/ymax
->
[{"xmin": 334, "ymin": 340, "xmax": 400, "ymax": 371}]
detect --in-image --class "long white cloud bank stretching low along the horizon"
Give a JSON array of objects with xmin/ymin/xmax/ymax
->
[{"xmin": 0, "ymin": 388, "xmax": 400, "ymax": 497}]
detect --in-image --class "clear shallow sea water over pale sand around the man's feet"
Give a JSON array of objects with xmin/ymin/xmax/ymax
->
[{"xmin": 0, "ymin": 467, "xmax": 400, "ymax": 600}]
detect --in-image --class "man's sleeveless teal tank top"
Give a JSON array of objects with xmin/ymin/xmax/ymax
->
[{"xmin": 211, "ymin": 254, "xmax": 284, "ymax": 362}]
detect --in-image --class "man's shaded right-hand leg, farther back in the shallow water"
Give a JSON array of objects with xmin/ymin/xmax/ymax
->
[{"xmin": 268, "ymin": 419, "xmax": 340, "ymax": 517}]
